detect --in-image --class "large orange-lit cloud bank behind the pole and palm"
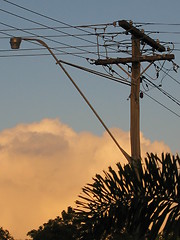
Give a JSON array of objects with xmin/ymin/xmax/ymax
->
[{"xmin": 0, "ymin": 119, "xmax": 170, "ymax": 238}]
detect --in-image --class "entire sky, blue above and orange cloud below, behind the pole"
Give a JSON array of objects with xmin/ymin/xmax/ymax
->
[{"xmin": 0, "ymin": 0, "xmax": 180, "ymax": 239}]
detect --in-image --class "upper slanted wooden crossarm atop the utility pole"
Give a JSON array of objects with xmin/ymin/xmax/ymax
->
[{"xmin": 118, "ymin": 20, "xmax": 166, "ymax": 52}]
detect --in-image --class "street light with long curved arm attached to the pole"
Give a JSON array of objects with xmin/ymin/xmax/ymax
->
[{"xmin": 10, "ymin": 37, "xmax": 132, "ymax": 164}]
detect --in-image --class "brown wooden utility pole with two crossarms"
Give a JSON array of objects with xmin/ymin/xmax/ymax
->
[{"xmin": 95, "ymin": 20, "xmax": 174, "ymax": 162}]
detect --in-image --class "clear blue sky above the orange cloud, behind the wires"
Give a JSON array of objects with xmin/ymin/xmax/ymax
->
[{"xmin": 0, "ymin": 0, "xmax": 180, "ymax": 152}]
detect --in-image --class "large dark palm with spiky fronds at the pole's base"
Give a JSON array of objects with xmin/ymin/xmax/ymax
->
[{"xmin": 76, "ymin": 154, "xmax": 180, "ymax": 240}]
